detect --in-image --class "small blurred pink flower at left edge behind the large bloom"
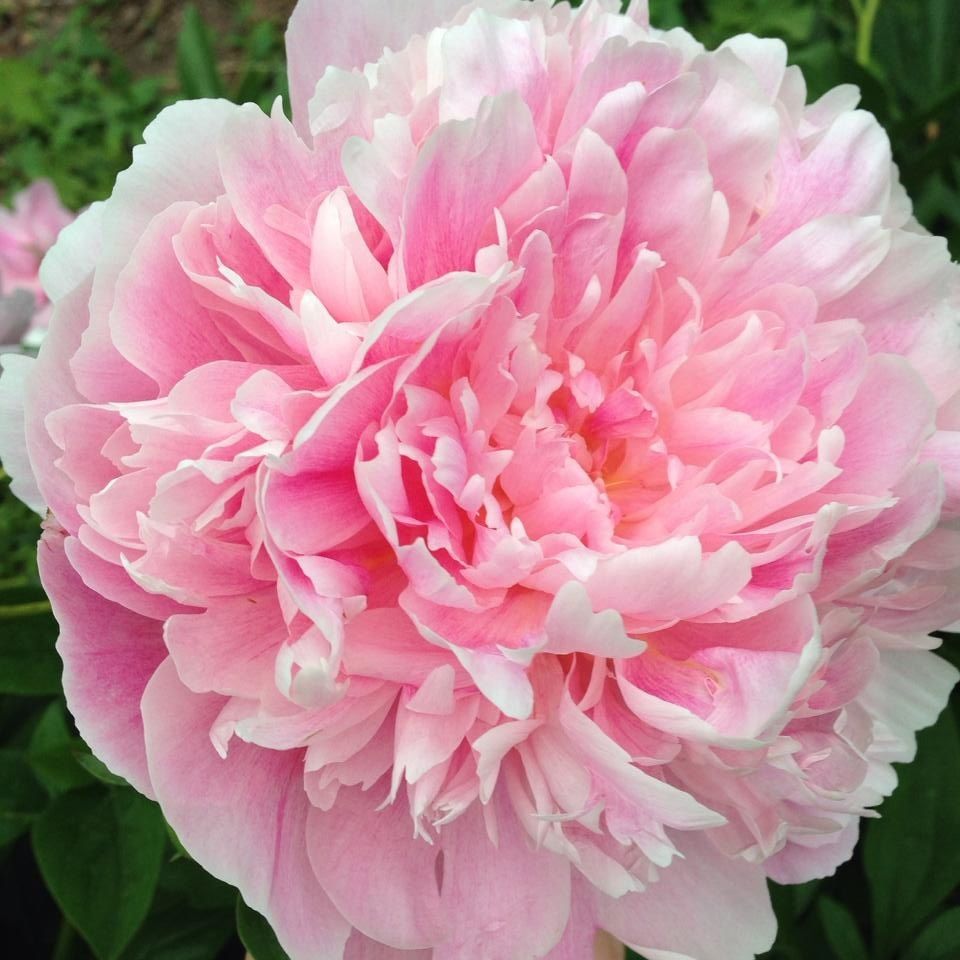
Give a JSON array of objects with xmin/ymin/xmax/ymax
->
[{"xmin": 0, "ymin": 180, "xmax": 73, "ymax": 350}]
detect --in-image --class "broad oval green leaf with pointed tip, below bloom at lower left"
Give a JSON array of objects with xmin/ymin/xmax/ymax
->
[{"xmin": 33, "ymin": 787, "xmax": 166, "ymax": 960}]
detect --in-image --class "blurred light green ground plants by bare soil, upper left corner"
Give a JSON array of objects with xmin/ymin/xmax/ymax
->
[{"xmin": 0, "ymin": 0, "xmax": 286, "ymax": 210}]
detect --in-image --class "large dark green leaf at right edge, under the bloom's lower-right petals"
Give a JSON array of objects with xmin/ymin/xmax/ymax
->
[{"xmin": 863, "ymin": 710, "xmax": 960, "ymax": 960}]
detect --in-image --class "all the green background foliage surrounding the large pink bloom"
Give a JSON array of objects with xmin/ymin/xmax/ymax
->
[{"xmin": 0, "ymin": 0, "xmax": 960, "ymax": 960}]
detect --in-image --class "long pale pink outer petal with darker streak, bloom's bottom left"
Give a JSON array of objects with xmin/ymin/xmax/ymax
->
[{"xmin": 143, "ymin": 660, "xmax": 350, "ymax": 960}]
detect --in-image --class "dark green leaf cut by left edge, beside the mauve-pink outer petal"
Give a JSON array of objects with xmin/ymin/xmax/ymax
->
[{"xmin": 0, "ymin": 600, "xmax": 61, "ymax": 696}]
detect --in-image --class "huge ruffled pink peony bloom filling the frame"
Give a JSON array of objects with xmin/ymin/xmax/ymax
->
[{"xmin": 0, "ymin": 0, "xmax": 960, "ymax": 960}]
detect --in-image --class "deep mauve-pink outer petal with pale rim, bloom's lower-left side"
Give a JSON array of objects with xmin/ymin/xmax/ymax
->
[{"xmin": 38, "ymin": 530, "xmax": 166, "ymax": 796}]
